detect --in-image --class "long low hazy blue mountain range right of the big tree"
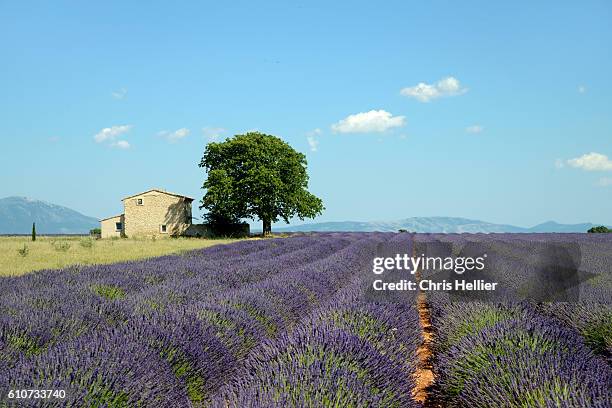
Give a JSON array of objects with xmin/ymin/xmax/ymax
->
[{"xmin": 273, "ymin": 217, "xmax": 608, "ymax": 233}]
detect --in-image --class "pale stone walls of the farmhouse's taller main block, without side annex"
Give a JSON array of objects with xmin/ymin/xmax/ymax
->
[{"xmin": 123, "ymin": 191, "xmax": 191, "ymax": 237}]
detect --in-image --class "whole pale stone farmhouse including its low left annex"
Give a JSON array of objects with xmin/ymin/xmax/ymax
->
[{"xmin": 100, "ymin": 189, "xmax": 193, "ymax": 238}]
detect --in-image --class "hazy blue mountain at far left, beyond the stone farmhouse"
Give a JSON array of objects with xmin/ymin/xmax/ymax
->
[{"xmin": 0, "ymin": 197, "xmax": 100, "ymax": 234}]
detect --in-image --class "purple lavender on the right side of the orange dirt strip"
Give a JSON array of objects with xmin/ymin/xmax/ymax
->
[{"xmin": 415, "ymin": 234, "xmax": 612, "ymax": 407}]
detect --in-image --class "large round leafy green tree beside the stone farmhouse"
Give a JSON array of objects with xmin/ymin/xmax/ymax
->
[{"xmin": 200, "ymin": 132, "xmax": 324, "ymax": 235}]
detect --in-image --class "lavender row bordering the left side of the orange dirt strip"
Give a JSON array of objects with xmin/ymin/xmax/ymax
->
[{"xmin": 212, "ymin": 235, "xmax": 423, "ymax": 408}]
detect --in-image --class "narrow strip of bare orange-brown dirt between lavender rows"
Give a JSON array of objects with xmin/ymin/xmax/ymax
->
[{"xmin": 412, "ymin": 242, "xmax": 435, "ymax": 407}]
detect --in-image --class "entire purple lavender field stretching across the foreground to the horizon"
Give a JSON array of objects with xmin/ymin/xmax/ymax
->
[{"xmin": 0, "ymin": 233, "xmax": 612, "ymax": 407}]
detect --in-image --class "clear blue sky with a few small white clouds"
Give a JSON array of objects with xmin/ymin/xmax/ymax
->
[{"xmin": 0, "ymin": 1, "xmax": 612, "ymax": 226}]
